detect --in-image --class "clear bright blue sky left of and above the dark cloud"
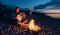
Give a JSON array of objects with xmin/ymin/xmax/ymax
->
[{"xmin": 0, "ymin": 0, "xmax": 51, "ymax": 9}]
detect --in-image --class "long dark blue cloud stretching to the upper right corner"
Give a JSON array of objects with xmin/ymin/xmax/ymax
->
[{"xmin": 34, "ymin": 0, "xmax": 60, "ymax": 10}]
